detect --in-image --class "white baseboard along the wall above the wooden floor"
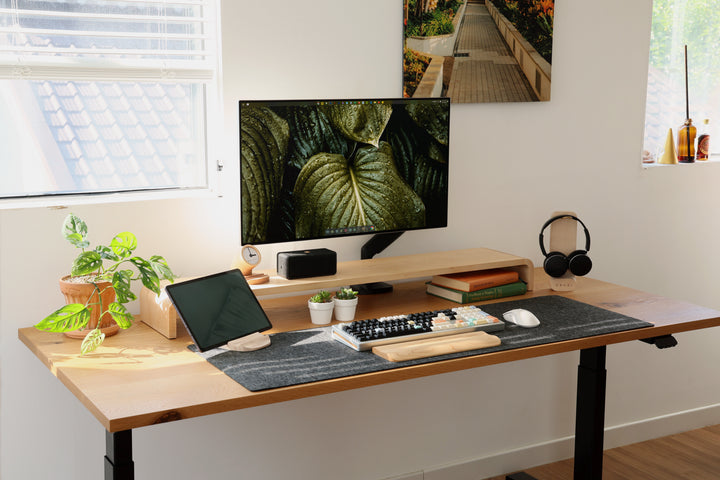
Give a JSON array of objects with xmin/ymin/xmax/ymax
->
[{"xmin": 408, "ymin": 404, "xmax": 720, "ymax": 480}]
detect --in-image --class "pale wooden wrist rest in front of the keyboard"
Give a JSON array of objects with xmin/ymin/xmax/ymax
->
[{"xmin": 372, "ymin": 331, "xmax": 500, "ymax": 362}]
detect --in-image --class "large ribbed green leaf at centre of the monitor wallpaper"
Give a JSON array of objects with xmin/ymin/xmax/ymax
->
[{"xmin": 294, "ymin": 142, "xmax": 425, "ymax": 238}]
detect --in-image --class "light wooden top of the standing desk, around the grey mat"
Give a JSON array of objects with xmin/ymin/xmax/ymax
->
[{"xmin": 18, "ymin": 269, "xmax": 720, "ymax": 432}]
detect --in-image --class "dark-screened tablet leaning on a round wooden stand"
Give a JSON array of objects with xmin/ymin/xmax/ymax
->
[{"xmin": 165, "ymin": 269, "xmax": 272, "ymax": 352}]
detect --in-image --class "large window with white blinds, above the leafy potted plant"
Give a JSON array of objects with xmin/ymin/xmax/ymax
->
[{"xmin": 0, "ymin": 0, "xmax": 218, "ymax": 198}]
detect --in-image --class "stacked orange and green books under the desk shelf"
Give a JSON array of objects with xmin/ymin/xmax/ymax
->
[{"xmin": 427, "ymin": 268, "xmax": 527, "ymax": 303}]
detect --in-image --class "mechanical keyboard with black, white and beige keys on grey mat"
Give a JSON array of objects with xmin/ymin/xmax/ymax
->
[{"xmin": 332, "ymin": 305, "xmax": 505, "ymax": 351}]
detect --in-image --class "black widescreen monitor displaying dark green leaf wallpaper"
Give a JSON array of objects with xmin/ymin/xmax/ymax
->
[{"xmin": 239, "ymin": 98, "xmax": 450, "ymax": 248}]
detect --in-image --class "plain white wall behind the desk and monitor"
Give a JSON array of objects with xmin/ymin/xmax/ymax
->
[{"xmin": 0, "ymin": 0, "xmax": 720, "ymax": 480}]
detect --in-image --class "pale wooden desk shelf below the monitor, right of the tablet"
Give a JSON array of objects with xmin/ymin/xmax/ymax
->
[{"xmin": 252, "ymin": 248, "xmax": 534, "ymax": 297}]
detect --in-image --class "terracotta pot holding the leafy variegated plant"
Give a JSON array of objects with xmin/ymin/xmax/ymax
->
[{"xmin": 60, "ymin": 275, "xmax": 120, "ymax": 339}]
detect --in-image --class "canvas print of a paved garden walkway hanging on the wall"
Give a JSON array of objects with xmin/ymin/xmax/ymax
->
[{"xmin": 403, "ymin": 0, "xmax": 555, "ymax": 103}]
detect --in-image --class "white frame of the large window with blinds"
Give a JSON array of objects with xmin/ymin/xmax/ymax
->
[{"xmin": 0, "ymin": 0, "xmax": 223, "ymax": 210}]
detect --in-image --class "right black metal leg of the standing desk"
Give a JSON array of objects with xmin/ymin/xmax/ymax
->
[{"xmin": 573, "ymin": 346, "xmax": 607, "ymax": 480}]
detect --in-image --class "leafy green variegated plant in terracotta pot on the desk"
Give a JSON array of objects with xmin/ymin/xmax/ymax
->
[{"xmin": 35, "ymin": 213, "xmax": 175, "ymax": 355}]
